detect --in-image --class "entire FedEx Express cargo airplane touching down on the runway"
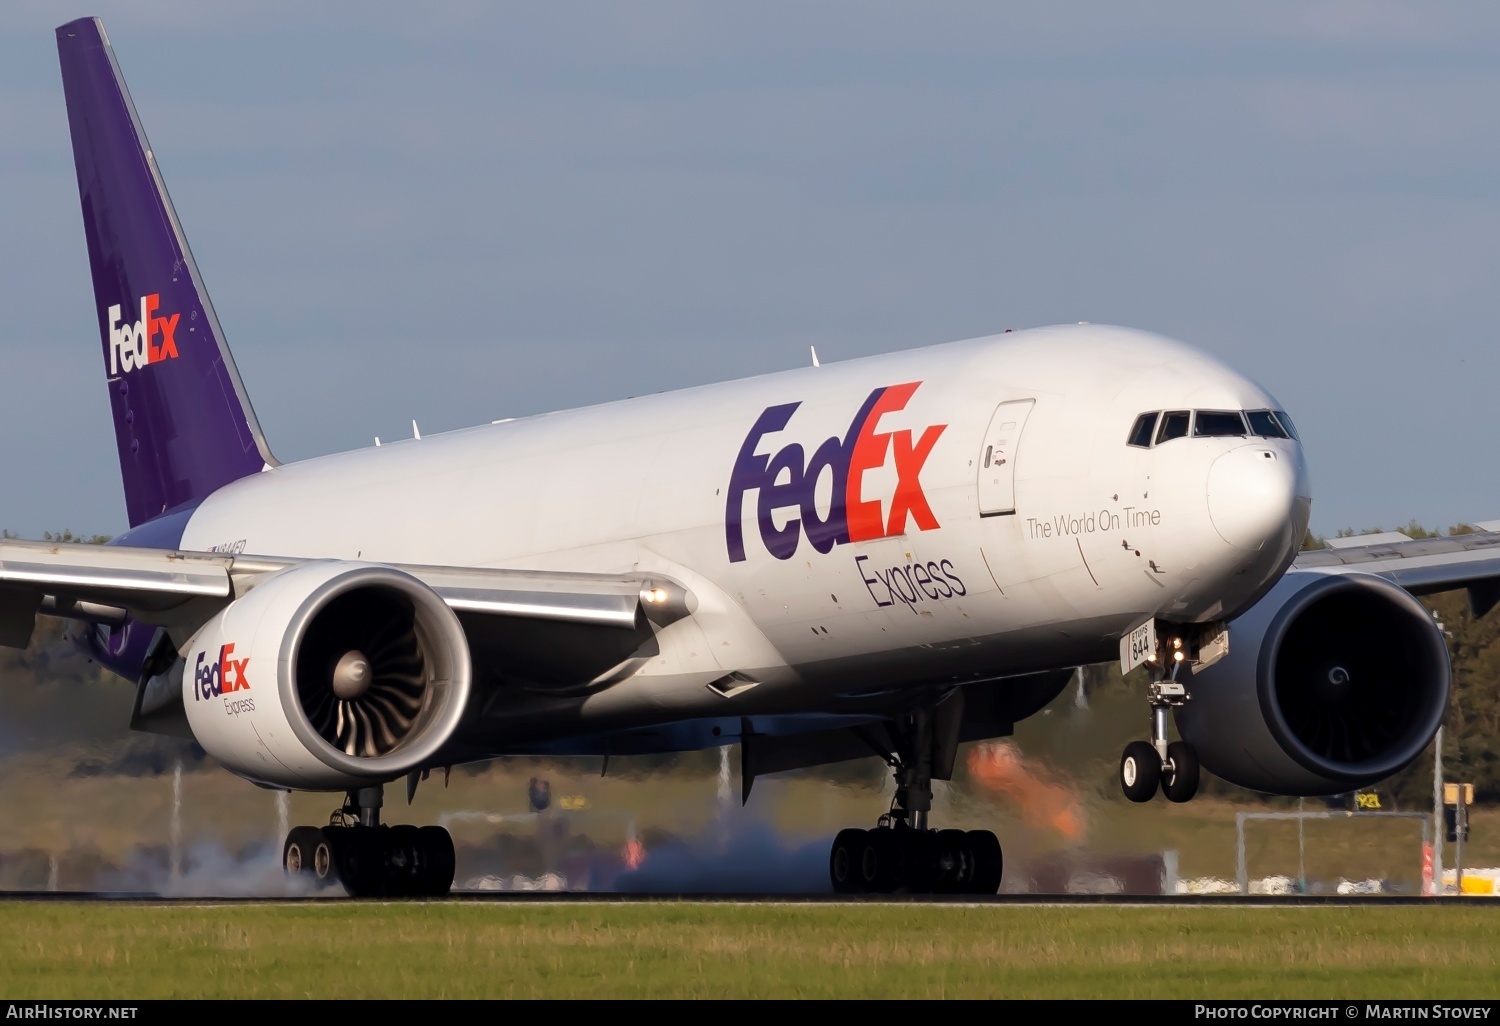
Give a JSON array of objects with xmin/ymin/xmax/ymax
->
[{"xmin": 0, "ymin": 20, "xmax": 1500, "ymax": 894}]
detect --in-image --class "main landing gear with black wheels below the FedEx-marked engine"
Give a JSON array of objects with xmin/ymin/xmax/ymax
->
[{"xmin": 282, "ymin": 786, "xmax": 455, "ymax": 897}]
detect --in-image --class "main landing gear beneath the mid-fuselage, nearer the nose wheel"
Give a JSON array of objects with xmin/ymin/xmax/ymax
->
[{"xmin": 828, "ymin": 692, "xmax": 1004, "ymax": 894}]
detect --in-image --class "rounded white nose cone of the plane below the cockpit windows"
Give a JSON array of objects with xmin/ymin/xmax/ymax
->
[{"xmin": 1208, "ymin": 446, "xmax": 1311, "ymax": 552}]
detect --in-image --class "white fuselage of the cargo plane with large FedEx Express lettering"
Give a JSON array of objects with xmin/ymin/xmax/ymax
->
[{"xmin": 170, "ymin": 326, "xmax": 1310, "ymax": 741}]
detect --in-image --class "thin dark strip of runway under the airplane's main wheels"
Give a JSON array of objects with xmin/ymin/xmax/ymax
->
[{"xmin": 0, "ymin": 891, "xmax": 1500, "ymax": 911}]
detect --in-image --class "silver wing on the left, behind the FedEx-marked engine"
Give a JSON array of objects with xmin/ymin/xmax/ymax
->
[{"xmin": 0, "ymin": 540, "xmax": 687, "ymax": 648}]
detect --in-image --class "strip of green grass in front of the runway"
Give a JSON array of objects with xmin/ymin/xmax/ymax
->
[{"xmin": 0, "ymin": 903, "xmax": 1500, "ymax": 999}]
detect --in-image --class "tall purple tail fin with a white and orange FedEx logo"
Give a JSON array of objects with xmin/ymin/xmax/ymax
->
[{"xmin": 57, "ymin": 18, "xmax": 276, "ymax": 527}]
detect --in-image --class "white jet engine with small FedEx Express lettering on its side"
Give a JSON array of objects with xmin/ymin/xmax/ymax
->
[{"xmin": 183, "ymin": 561, "xmax": 471, "ymax": 791}]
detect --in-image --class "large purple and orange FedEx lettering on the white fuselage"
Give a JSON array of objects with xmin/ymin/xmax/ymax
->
[{"xmin": 725, "ymin": 381, "xmax": 948, "ymax": 563}]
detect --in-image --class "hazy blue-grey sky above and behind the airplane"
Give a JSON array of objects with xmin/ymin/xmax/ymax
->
[{"xmin": 0, "ymin": 0, "xmax": 1500, "ymax": 536}]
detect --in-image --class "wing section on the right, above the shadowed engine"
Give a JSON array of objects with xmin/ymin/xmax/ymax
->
[{"xmin": 1293, "ymin": 522, "xmax": 1500, "ymax": 617}]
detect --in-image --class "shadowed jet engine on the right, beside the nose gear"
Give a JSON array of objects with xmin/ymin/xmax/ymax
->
[{"xmin": 1176, "ymin": 572, "xmax": 1449, "ymax": 795}]
